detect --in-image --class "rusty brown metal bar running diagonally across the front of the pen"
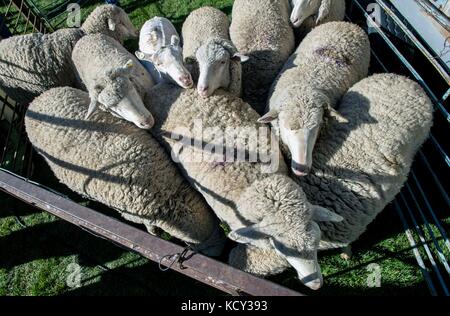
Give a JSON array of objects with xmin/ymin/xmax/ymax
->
[{"xmin": 0, "ymin": 170, "xmax": 302, "ymax": 296}]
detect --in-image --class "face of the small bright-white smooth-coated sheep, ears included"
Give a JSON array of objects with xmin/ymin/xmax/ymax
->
[{"xmin": 136, "ymin": 35, "xmax": 194, "ymax": 89}]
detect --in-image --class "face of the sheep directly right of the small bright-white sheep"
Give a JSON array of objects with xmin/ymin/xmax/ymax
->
[{"xmin": 196, "ymin": 40, "xmax": 248, "ymax": 98}]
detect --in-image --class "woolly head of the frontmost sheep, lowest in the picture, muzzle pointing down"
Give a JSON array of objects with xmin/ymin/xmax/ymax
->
[{"xmin": 228, "ymin": 176, "xmax": 343, "ymax": 290}]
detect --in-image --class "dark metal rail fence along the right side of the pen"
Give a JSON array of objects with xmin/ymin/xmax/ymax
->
[{"xmin": 348, "ymin": 0, "xmax": 450, "ymax": 296}]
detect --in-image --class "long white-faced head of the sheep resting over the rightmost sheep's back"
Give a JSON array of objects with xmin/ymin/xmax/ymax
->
[{"xmin": 259, "ymin": 87, "xmax": 328, "ymax": 177}]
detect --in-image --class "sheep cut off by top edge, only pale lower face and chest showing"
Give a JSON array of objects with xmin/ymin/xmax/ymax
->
[{"xmin": 291, "ymin": 0, "xmax": 345, "ymax": 39}]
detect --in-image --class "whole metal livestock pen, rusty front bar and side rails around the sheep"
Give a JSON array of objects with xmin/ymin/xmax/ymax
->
[{"xmin": 0, "ymin": 0, "xmax": 450, "ymax": 296}]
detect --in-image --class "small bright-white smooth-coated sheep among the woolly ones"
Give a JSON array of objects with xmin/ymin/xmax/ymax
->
[{"xmin": 135, "ymin": 17, "xmax": 193, "ymax": 89}]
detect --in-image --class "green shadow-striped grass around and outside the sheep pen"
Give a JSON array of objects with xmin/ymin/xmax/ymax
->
[{"xmin": 0, "ymin": 0, "xmax": 450, "ymax": 295}]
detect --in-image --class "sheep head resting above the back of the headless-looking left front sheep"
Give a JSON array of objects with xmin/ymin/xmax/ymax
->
[{"xmin": 86, "ymin": 60, "xmax": 154, "ymax": 129}]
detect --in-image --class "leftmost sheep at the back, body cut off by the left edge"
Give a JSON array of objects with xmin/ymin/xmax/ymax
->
[{"xmin": 0, "ymin": 5, "xmax": 135, "ymax": 104}]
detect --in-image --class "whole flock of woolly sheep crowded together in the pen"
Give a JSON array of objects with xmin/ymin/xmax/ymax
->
[{"xmin": 0, "ymin": 0, "xmax": 433, "ymax": 289}]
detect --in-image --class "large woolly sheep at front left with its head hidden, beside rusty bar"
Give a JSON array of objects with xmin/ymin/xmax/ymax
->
[{"xmin": 25, "ymin": 87, "xmax": 224, "ymax": 255}]
